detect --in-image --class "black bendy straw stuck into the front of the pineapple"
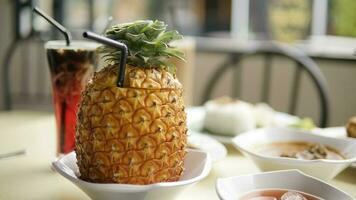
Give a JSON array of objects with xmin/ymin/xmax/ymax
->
[{"xmin": 83, "ymin": 31, "xmax": 128, "ymax": 87}]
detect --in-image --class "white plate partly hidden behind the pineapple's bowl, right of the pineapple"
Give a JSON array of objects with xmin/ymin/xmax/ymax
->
[{"xmin": 188, "ymin": 130, "xmax": 227, "ymax": 162}]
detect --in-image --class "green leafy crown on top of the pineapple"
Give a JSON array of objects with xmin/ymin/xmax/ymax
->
[{"xmin": 99, "ymin": 20, "xmax": 185, "ymax": 74}]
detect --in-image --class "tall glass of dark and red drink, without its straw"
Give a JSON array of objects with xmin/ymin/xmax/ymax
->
[{"xmin": 45, "ymin": 41, "xmax": 98, "ymax": 154}]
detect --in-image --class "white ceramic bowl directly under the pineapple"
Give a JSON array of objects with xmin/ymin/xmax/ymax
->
[{"xmin": 52, "ymin": 150, "xmax": 212, "ymax": 200}]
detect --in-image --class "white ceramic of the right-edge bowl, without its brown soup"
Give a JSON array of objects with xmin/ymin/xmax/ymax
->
[{"xmin": 233, "ymin": 127, "xmax": 356, "ymax": 180}]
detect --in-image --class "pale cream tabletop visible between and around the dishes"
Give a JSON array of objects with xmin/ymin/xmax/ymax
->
[{"xmin": 0, "ymin": 111, "xmax": 356, "ymax": 200}]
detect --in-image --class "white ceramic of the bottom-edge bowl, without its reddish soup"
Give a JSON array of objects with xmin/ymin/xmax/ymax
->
[{"xmin": 216, "ymin": 170, "xmax": 353, "ymax": 200}]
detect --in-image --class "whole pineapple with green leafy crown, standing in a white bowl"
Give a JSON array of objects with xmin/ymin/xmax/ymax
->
[{"xmin": 75, "ymin": 21, "xmax": 187, "ymax": 185}]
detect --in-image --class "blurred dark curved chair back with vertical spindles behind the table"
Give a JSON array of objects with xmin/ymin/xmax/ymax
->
[{"xmin": 202, "ymin": 42, "xmax": 329, "ymax": 127}]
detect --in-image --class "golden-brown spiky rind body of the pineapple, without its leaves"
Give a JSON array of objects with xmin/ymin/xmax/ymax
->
[{"xmin": 75, "ymin": 65, "xmax": 187, "ymax": 184}]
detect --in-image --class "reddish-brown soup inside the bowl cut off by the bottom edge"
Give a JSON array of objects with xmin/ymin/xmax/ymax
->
[{"xmin": 238, "ymin": 189, "xmax": 322, "ymax": 200}]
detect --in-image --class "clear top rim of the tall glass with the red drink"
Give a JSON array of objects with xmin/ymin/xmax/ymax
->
[{"xmin": 44, "ymin": 40, "xmax": 100, "ymax": 50}]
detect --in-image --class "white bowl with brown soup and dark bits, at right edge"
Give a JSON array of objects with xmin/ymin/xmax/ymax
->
[{"xmin": 233, "ymin": 127, "xmax": 356, "ymax": 180}]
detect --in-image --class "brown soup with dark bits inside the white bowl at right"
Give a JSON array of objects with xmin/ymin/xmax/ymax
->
[{"xmin": 255, "ymin": 141, "xmax": 345, "ymax": 160}]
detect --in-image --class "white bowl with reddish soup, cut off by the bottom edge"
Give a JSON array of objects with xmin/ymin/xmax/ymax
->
[{"xmin": 216, "ymin": 170, "xmax": 353, "ymax": 200}]
